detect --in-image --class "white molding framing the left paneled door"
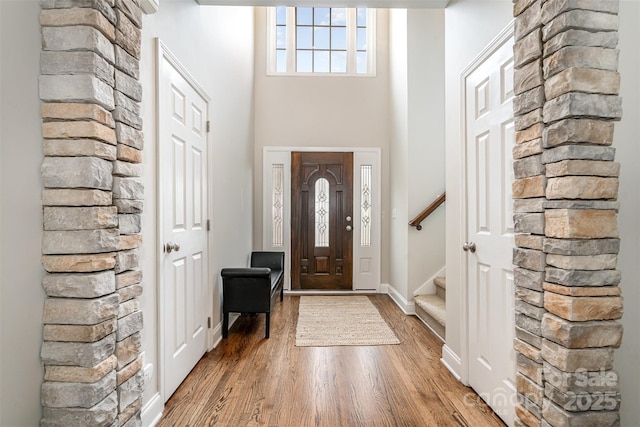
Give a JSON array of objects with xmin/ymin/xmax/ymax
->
[{"xmin": 153, "ymin": 38, "xmax": 214, "ymax": 407}]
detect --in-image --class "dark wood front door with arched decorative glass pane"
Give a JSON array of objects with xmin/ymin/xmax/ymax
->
[{"xmin": 291, "ymin": 152, "xmax": 353, "ymax": 289}]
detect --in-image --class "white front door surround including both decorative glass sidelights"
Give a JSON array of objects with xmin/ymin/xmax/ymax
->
[{"xmin": 262, "ymin": 147, "xmax": 382, "ymax": 292}]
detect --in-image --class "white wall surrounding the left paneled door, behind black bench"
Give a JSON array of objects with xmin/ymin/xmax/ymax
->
[{"xmin": 141, "ymin": 0, "xmax": 254, "ymax": 420}]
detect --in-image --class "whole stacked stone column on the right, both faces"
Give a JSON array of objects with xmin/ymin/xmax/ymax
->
[{"xmin": 513, "ymin": 0, "xmax": 622, "ymax": 427}]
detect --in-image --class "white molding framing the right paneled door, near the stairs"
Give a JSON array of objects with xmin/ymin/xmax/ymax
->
[{"xmin": 442, "ymin": 20, "xmax": 515, "ymax": 385}]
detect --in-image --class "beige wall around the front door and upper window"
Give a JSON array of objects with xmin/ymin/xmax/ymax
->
[{"xmin": 254, "ymin": 8, "xmax": 390, "ymax": 282}]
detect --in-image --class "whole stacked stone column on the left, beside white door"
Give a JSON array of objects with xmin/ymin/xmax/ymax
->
[{"xmin": 40, "ymin": 0, "xmax": 143, "ymax": 426}]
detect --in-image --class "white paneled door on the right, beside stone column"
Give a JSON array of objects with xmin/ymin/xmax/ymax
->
[{"xmin": 465, "ymin": 29, "xmax": 516, "ymax": 425}]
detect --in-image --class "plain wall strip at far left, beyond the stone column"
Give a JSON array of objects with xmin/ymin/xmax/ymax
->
[{"xmin": 0, "ymin": 0, "xmax": 44, "ymax": 426}]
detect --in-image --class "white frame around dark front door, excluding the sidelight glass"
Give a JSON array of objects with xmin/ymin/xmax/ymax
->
[{"xmin": 262, "ymin": 146, "xmax": 382, "ymax": 293}]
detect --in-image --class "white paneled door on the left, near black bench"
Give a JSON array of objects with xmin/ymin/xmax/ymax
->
[{"xmin": 158, "ymin": 43, "xmax": 209, "ymax": 401}]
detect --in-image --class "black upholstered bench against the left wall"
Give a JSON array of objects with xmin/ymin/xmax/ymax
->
[{"xmin": 220, "ymin": 252, "xmax": 284, "ymax": 338}]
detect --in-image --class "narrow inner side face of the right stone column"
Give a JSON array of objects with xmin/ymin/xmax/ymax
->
[{"xmin": 512, "ymin": 0, "xmax": 547, "ymax": 426}]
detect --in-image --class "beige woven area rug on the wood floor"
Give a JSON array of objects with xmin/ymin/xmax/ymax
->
[{"xmin": 296, "ymin": 295, "xmax": 400, "ymax": 347}]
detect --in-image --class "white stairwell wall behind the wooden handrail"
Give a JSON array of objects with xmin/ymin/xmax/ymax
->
[{"xmin": 403, "ymin": 9, "xmax": 446, "ymax": 300}]
